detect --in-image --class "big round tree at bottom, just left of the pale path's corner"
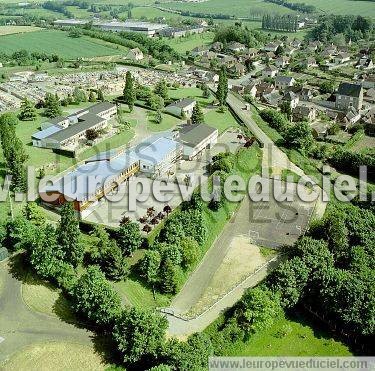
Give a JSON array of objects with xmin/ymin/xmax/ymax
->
[{"xmin": 112, "ymin": 308, "xmax": 168, "ymax": 363}]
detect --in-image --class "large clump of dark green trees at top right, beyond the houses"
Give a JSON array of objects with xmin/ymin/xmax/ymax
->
[{"xmin": 308, "ymin": 15, "xmax": 374, "ymax": 42}]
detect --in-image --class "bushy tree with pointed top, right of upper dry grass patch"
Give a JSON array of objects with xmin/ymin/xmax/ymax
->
[{"xmin": 72, "ymin": 266, "xmax": 121, "ymax": 328}]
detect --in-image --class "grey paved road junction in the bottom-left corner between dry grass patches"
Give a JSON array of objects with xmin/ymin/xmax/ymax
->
[{"xmin": 0, "ymin": 262, "xmax": 93, "ymax": 368}]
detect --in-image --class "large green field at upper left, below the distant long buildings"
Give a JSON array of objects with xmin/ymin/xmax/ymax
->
[{"xmin": 0, "ymin": 30, "xmax": 119, "ymax": 59}]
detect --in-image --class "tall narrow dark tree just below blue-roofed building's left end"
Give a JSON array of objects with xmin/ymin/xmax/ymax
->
[{"xmin": 56, "ymin": 202, "xmax": 84, "ymax": 267}]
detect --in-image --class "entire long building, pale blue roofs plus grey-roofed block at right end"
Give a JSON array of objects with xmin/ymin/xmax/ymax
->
[{"xmin": 40, "ymin": 120, "xmax": 218, "ymax": 218}]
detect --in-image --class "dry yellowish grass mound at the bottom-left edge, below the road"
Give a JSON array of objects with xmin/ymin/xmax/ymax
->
[{"xmin": 0, "ymin": 342, "xmax": 106, "ymax": 371}]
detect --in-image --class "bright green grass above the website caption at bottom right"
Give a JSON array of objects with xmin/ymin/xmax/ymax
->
[{"xmin": 205, "ymin": 313, "xmax": 352, "ymax": 357}]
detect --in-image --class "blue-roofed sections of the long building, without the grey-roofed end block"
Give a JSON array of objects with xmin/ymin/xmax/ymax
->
[{"xmin": 40, "ymin": 135, "xmax": 182, "ymax": 217}]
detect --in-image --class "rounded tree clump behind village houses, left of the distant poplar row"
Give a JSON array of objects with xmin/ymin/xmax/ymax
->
[{"xmin": 214, "ymin": 25, "xmax": 269, "ymax": 48}]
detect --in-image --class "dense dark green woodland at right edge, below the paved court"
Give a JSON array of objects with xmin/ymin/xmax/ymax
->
[{"xmin": 270, "ymin": 203, "xmax": 375, "ymax": 346}]
